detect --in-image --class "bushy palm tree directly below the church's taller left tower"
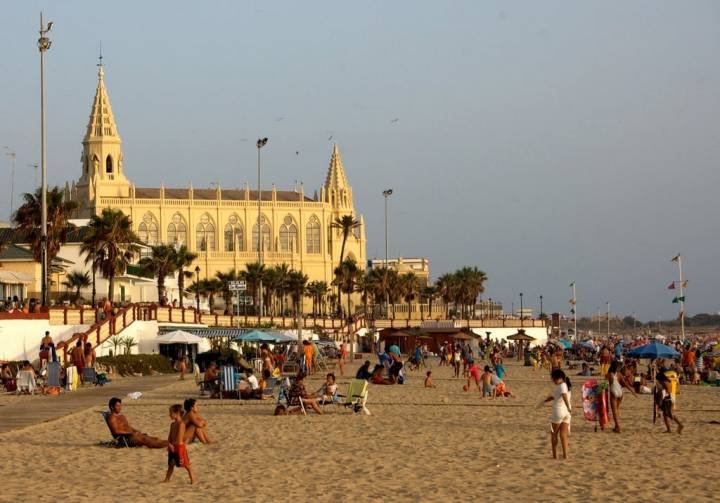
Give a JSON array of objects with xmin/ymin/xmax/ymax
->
[{"xmin": 80, "ymin": 208, "xmax": 140, "ymax": 301}]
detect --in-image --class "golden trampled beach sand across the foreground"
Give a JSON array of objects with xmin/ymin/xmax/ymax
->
[{"xmin": 0, "ymin": 362, "xmax": 720, "ymax": 503}]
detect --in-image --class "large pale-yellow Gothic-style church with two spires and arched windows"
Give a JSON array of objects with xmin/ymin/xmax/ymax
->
[{"xmin": 66, "ymin": 66, "xmax": 366, "ymax": 302}]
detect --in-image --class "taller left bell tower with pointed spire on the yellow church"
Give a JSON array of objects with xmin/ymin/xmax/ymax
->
[{"xmin": 76, "ymin": 63, "xmax": 130, "ymax": 217}]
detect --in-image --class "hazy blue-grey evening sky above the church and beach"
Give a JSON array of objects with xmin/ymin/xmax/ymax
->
[{"xmin": 0, "ymin": 0, "xmax": 720, "ymax": 321}]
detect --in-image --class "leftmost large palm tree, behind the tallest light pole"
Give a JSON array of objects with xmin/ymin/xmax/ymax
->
[{"xmin": 12, "ymin": 187, "xmax": 77, "ymax": 292}]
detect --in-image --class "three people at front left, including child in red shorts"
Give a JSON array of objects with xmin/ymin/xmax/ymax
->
[{"xmin": 107, "ymin": 397, "xmax": 212, "ymax": 484}]
